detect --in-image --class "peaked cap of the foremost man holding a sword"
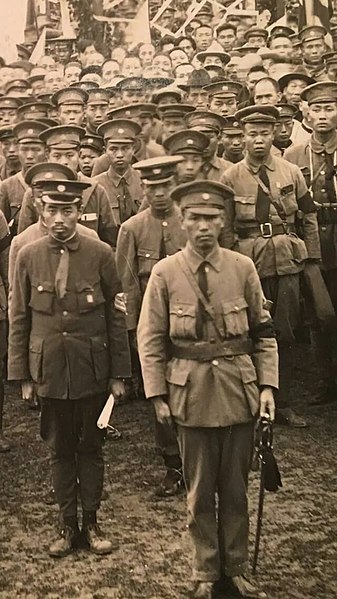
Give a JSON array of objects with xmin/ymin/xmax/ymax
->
[{"xmin": 171, "ymin": 180, "xmax": 234, "ymax": 216}]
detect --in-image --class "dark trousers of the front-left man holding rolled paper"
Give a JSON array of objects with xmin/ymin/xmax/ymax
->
[{"xmin": 40, "ymin": 394, "xmax": 107, "ymax": 521}]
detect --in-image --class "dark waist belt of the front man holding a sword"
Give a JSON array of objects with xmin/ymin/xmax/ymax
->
[{"xmin": 171, "ymin": 338, "xmax": 253, "ymax": 362}]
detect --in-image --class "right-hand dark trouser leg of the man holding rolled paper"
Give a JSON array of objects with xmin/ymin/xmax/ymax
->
[{"xmin": 76, "ymin": 396, "xmax": 107, "ymax": 512}]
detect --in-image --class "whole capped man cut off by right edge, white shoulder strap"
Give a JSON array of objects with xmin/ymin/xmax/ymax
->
[{"xmin": 284, "ymin": 81, "xmax": 337, "ymax": 403}]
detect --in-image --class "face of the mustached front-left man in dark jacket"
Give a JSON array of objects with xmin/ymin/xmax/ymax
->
[{"xmin": 42, "ymin": 202, "xmax": 81, "ymax": 240}]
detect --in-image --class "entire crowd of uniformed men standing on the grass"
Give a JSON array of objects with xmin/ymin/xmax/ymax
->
[{"xmin": 0, "ymin": 6, "xmax": 337, "ymax": 599}]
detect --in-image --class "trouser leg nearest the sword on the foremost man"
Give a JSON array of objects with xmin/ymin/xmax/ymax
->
[{"xmin": 218, "ymin": 423, "xmax": 254, "ymax": 577}]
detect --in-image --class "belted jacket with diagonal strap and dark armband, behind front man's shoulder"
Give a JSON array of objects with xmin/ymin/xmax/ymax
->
[{"xmin": 222, "ymin": 154, "xmax": 321, "ymax": 278}]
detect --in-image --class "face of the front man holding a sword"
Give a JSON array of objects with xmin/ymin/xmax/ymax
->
[{"xmin": 181, "ymin": 208, "xmax": 224, "ymax": 256}]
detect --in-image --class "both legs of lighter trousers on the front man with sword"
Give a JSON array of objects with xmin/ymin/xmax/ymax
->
[{"xmin": 177, "ymin": 422, "xmax": 254, "ymax": 582}]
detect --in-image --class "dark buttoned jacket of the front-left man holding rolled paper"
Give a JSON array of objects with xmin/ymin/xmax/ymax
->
[{"xmin": 8, "ymin": 233, "xmax": 130, "ymax": 399}]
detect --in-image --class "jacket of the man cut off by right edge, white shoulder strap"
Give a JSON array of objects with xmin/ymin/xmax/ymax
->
[{"xmin": 284, "ymin": 132, "xmax": 337, "ymax": 270}]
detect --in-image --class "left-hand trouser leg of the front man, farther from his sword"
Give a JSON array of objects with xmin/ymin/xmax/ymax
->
[{"xmin": 178, "ymin": 426, "xmax": 220, "ymax": 582}]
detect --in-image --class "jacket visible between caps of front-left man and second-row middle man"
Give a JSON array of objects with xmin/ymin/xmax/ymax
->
[{"xmin": 94, "ymin": 166, "xmax": 144, "ymax": 225}]
